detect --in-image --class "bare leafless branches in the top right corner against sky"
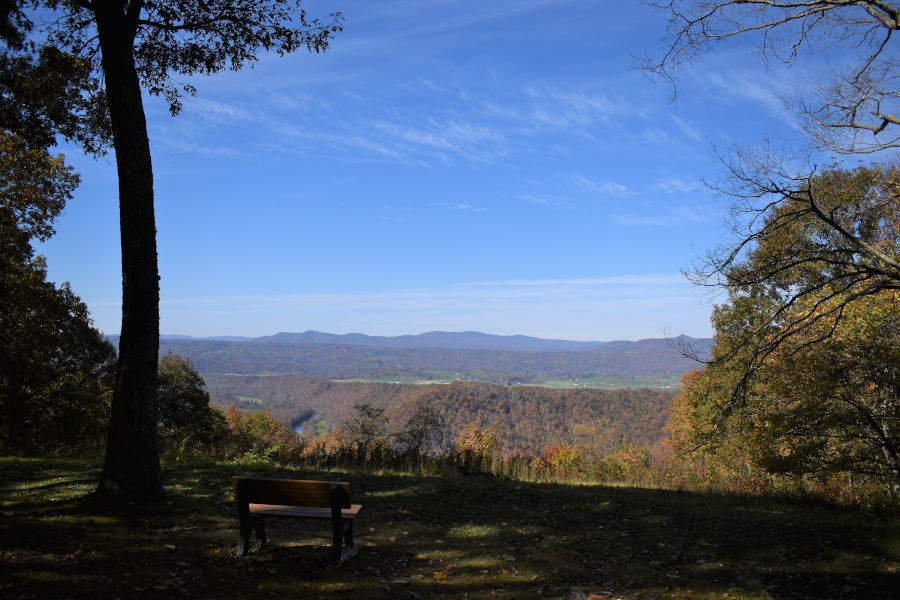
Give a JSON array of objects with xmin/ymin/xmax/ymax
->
[{"xmin": 640, "ymin": 0, "xmax": 900, "ymax": 154}]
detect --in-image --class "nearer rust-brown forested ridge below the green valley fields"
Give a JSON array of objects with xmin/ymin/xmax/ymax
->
[{"xmin": 205, "ymin": 375, "xmax": 673, "ymax": 453}]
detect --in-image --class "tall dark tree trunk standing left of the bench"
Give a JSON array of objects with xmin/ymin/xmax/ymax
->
[{"xmin": 93, "ymin": 2, "xmax": 163, "ymax": 497}]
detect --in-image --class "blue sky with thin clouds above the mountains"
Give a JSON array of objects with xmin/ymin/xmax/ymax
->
[{"xmin": 37, "ymin": 0, "xmax": 816, "ymax": 341}]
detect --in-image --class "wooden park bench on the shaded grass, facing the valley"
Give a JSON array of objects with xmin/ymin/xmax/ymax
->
[{"xmin": 231, "ymin": 476, "xmax": 362, "ymax": 563}]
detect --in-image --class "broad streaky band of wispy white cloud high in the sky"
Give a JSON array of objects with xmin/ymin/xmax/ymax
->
[{"xmin": 156, "ymin": 59, "xmax": 644, "ymax": 166}]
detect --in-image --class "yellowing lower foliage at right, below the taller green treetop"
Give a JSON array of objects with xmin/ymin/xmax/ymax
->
[{"xmin": 670, "ymin": 291, "xmax": 900, "ymax": 498}]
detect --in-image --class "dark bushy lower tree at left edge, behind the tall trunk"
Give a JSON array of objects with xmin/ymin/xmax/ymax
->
[{"xmin": 0, "ymin": 207, "xmax": 115, "ymax": 454}]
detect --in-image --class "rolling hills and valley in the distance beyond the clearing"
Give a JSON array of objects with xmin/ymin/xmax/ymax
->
[{"xmin": 148, "ymin": 331, "xmax": 711, "ymax": 452}]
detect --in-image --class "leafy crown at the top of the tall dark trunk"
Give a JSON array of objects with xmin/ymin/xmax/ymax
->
[{"xmin": 38, "ymin": 0, "xmax": 342, "ymax": 114}]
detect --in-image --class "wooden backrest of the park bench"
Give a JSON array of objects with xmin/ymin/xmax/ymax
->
[{"xmin": 231, "ymin": 476, "xmax": 350, "ymax": 508}]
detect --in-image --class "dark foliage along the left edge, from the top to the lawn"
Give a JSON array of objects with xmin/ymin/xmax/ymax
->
[{"xmin": 0, "ymin": 2, "xmax": 115, "ymax": 454}]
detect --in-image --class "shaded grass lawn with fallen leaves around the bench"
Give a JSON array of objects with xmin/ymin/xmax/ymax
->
[{"xmin": 0, "ymin": 459, "xmax": 900, "ymax": 600}]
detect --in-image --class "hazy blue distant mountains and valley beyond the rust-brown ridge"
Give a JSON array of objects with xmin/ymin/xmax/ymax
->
[{"xmin": 153, "ymin": 331, "xmax": 712, "ymax": 387}]
